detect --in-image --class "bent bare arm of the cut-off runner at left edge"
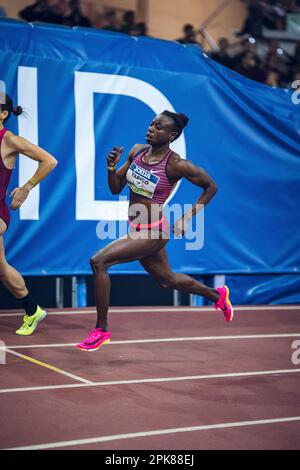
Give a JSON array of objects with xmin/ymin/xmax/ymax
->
[{"xmin": 5, "ymin": 134, "xmax": 57, "ymax": 210}]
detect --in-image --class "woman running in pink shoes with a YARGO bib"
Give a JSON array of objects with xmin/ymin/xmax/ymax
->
[{"xmin": 77, "ymin": 111, "xmax": 233, "ymax": 351}]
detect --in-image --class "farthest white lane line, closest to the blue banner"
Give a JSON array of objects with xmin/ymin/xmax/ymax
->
[{"xmin": 0, "ymin": 305, "xmax": 300, "ymax": 317}]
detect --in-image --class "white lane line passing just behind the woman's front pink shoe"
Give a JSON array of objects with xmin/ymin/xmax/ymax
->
[{"xmin": 5, "ymin": 333, "xmax": 300, "ymax": 350}]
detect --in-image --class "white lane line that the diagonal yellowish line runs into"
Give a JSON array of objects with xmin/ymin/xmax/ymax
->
[{"xmin": 0, "ymin": 369, "xmax": 300, "ymax": 394}]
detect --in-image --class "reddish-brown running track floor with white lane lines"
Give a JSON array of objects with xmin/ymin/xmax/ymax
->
[{"xmin": 0, "ymin": 306, "xmax": 300, "ymax": 450}]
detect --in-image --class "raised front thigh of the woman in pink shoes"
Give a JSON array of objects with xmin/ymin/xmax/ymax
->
[{"xmin": 92, "ymin": 231, "xmax": 167, "ymax": 266}]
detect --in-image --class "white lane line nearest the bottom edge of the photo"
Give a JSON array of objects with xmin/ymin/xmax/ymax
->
[{"xmin": 6, "ymin": 416, "xmax": 300, "ymax": 450}]
